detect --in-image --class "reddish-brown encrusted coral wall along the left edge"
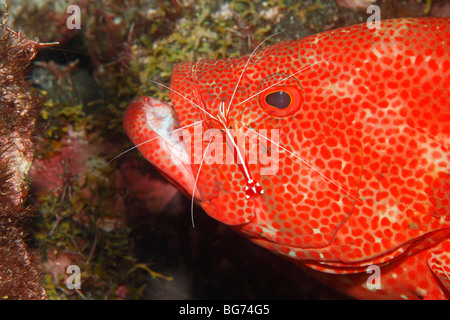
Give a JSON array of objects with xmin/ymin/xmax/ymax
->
[{"xmin": 0, "ymin": 5, "xmax": 47, "ymax": 299}]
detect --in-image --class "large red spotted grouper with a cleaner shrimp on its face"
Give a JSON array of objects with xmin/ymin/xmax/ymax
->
[{"xmin": 124, "ymin": 18, "xmax": 450, "ymax": 299}]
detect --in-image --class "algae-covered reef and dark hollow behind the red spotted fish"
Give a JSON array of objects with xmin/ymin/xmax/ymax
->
[{"xmin": 0, "ymin": 0, "xmax": 450, "ymax": 299}]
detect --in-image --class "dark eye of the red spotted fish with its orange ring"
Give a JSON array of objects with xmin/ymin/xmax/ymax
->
[{"xmin": 259, "ymin": 86, "xmax": 304, "ymax": 117}]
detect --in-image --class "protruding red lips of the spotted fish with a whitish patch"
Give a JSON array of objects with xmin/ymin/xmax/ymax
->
[{"xmin": 123, "ymin": 97, "xmax": 199, "ymax": 199}]
